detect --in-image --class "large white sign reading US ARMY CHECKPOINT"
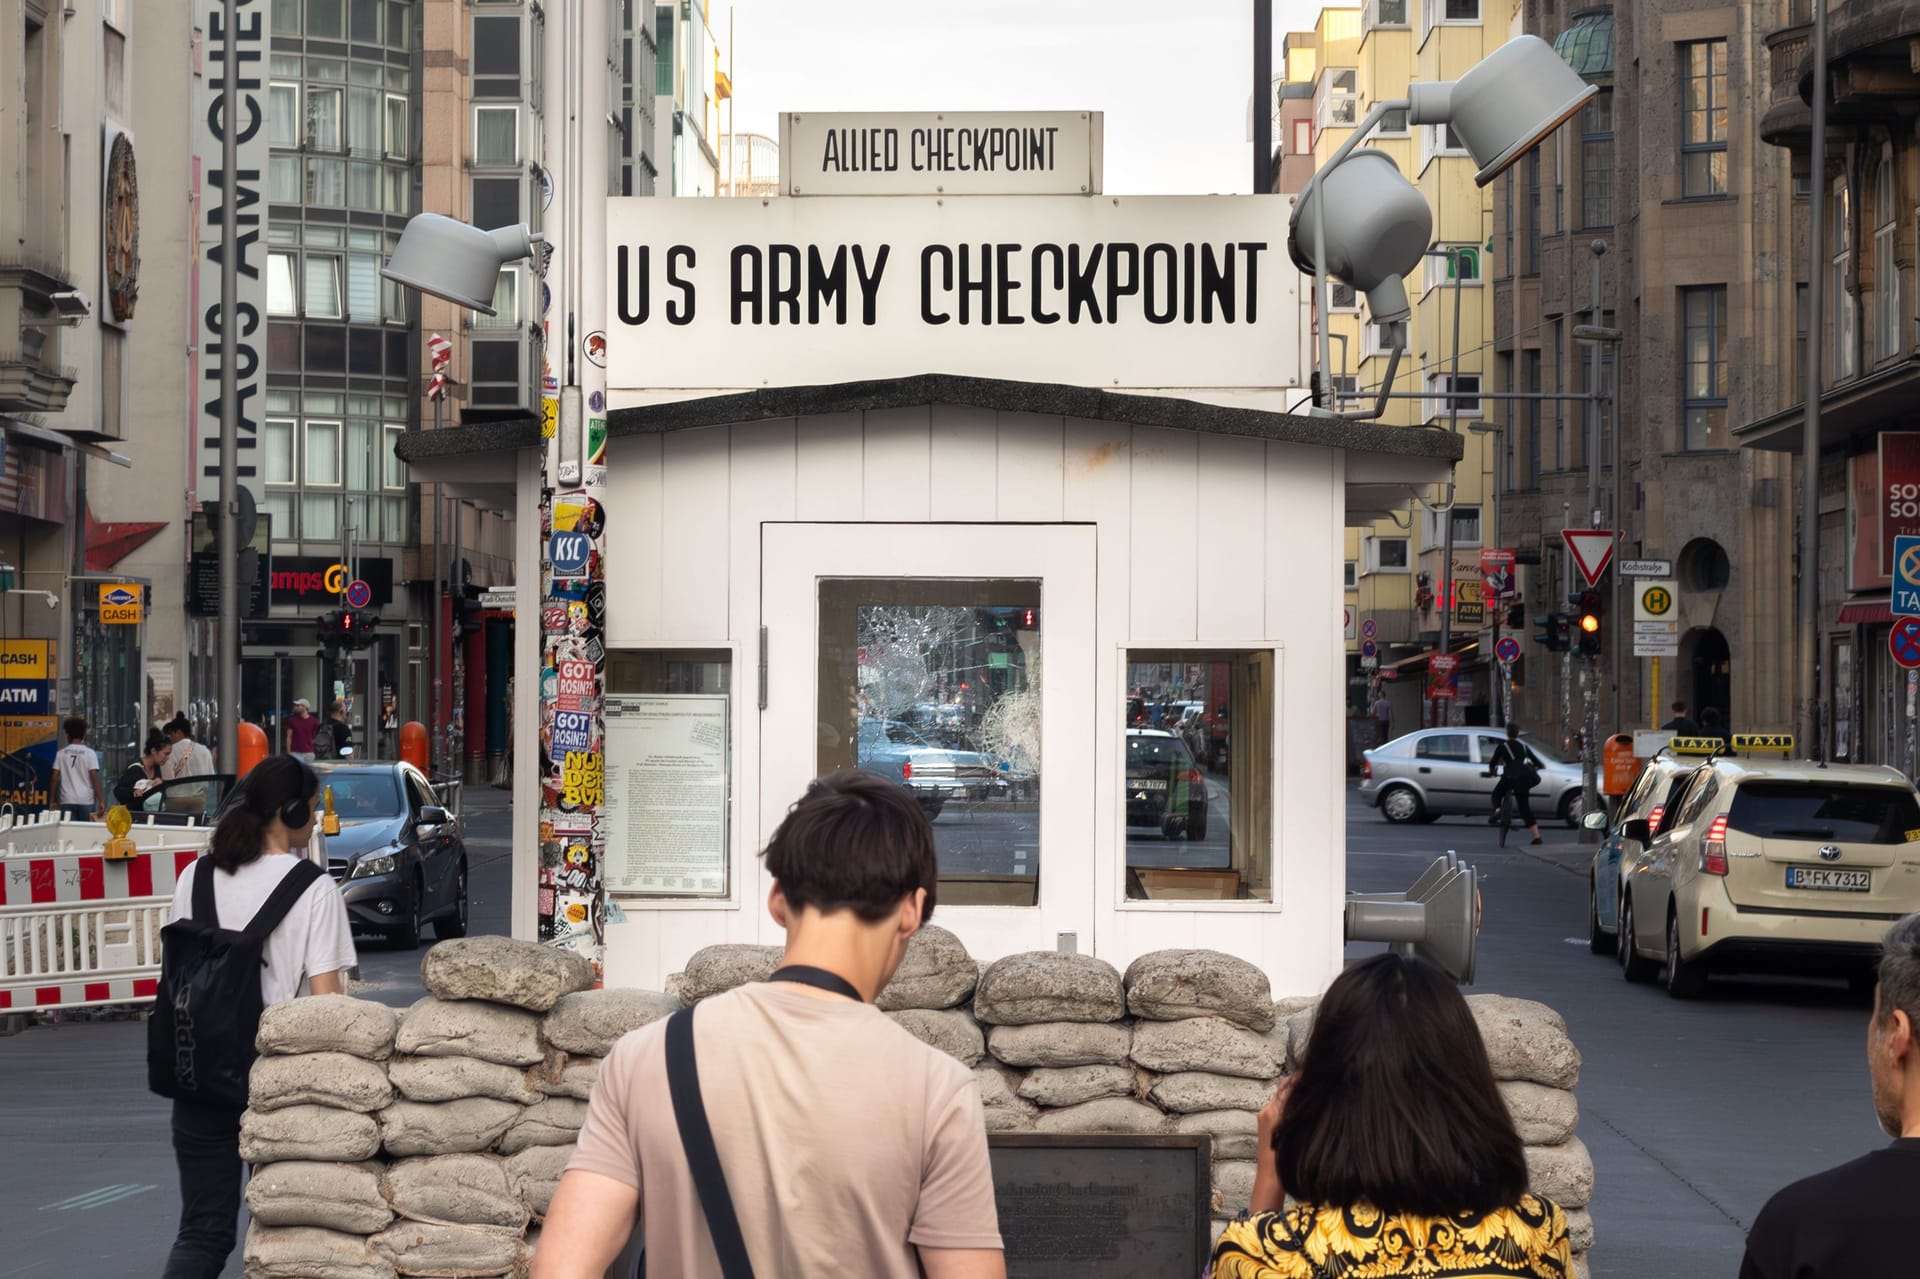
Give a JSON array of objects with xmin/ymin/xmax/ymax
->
[{"xmin": 607, "ymin": 196, "xmax": 1300, "ymax": 392}]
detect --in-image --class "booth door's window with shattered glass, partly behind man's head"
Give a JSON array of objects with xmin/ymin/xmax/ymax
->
[{"xmin": 818, "ymin": 578, "xmax": 1043, "ymax": 906}]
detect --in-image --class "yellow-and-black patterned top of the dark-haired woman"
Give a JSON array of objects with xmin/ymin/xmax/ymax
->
[{"xmin": 1213, "ymin": 1195, "xmax": 1574, "ymax": 1279}]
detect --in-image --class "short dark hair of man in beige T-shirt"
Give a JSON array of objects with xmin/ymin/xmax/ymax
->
[{"xmin": 766, "ymin": 770, "xmax": 939, "ymax": 924}]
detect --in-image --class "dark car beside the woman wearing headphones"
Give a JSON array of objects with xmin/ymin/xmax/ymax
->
[{"xmin": 313, "ymin": 760, "xmax": 467, "ymax": 949}]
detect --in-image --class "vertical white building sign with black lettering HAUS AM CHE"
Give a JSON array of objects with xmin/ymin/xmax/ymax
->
[{"xmin": 194, "ymin": 0, "xmax": 269, "ymax": 501}]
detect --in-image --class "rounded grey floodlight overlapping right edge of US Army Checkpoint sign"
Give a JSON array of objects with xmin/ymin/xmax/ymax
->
[{"xmin": 1286, "ymin": 148, "xmax": 1434, "ymax": 325}]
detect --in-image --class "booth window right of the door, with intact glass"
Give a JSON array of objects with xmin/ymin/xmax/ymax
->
[{"xmin": 1121, "ymin": 649, "xmax": 1275, "ymax": 901}]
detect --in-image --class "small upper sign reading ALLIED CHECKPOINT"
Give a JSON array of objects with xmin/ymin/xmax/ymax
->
[{"xmin": 780, "ymin": 111, "xmax": 1102, "ymax": 196}]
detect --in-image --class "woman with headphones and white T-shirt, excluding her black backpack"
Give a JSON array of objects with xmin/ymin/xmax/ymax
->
[{"xmin": 163, "ymin": 755, "xmax": 355, "ymax": 1279}]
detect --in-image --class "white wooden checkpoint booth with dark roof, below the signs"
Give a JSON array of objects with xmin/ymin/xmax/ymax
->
[{"xmin": 403, "ymin": 374, "xmax": 1459, "ymax": 991}]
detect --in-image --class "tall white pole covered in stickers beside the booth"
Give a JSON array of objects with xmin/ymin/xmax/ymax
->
[{"xmin": 532, "ymin": 4, "xmax": 609, "ymax": 970}]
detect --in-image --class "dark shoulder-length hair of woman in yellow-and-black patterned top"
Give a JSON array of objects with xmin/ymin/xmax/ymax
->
[{"xmin": 1273, "ymin": 954, "xmax": 1526, "ymax": 1216}]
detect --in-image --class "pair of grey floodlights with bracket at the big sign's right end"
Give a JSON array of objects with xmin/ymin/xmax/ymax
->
[{"xmin": 1288, "ymin": 35, "xmax": 1599, "ymax": 421}]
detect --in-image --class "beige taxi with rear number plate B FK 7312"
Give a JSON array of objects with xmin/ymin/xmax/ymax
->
[{"xmin": 1619, "ymin": 737, "xmax": 1920, "ymax": 999}]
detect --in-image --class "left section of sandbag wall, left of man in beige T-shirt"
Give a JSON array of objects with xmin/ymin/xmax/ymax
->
[{"xmin": 242, "ymin": 925, "xmax": 680, "ymax": 1279}]
